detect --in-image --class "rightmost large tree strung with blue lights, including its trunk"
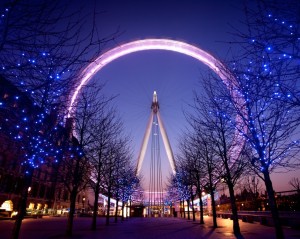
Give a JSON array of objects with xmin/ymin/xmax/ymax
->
[{"xmin": 229, "ymin": 1, "xmax": 300, "ymax": 238}]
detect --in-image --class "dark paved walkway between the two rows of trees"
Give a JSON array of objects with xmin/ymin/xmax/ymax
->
[{"xmin": 0, "ymin": 217, "xmax": 300, "ymax": 239}]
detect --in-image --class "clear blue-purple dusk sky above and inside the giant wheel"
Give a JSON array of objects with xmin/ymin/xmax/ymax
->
[{"xmin": 74, "ymin": 0, "xmax": 299, "ymax": 191}]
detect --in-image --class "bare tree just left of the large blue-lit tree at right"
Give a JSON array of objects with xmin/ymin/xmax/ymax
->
[{"xmin": 188, "ymin": 79, "xmax": 250, "ymax": 237}]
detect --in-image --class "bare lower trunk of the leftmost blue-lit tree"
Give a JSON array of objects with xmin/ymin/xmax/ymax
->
[{"xmin": 11, "ymin": 170, "xmax": 33, "ymax": 239}]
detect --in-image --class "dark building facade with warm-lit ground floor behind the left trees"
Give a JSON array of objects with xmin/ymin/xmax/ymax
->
[{"xmin": 0, "ymin": 77, "xmax": 89, "ymax": 216}]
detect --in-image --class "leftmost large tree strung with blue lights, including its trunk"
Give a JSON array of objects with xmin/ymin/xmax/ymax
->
[{"xmin": 0, "ymin": 0, "xmax": 116, "ymax": 238}]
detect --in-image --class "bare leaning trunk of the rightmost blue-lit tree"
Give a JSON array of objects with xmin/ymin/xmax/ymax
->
[{"xmin": 263, "ymin": 170, "xmax": 284, "ymax": 239}]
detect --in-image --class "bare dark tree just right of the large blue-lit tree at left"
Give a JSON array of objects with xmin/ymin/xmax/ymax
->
[{"xmin": 60, "ymin": 86, "xmax": 108, "ymax": 236}]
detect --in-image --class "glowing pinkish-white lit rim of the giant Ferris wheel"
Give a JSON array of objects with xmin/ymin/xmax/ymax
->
[{"xmin": 68, "ymin": 39, "xmax": 245, "ymax": 164}]
